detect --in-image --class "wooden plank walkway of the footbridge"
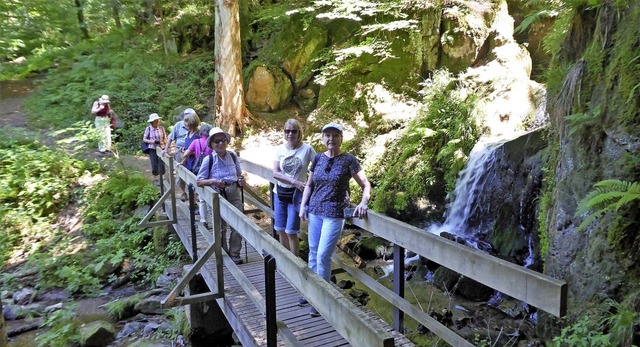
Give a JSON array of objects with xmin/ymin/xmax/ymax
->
[{"xmin": 165, "ymin": 200, "xmax": 414, "ymax": 347}]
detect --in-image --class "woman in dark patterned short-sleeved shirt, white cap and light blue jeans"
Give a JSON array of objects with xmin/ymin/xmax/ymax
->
[{"xmin": 300, "ymin": 122, "xmax": 371, "ymax": 317}]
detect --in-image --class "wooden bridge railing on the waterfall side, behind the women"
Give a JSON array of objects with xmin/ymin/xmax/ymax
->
[{"xmin": 242, "ymin": 160, "xmax": 567, "ymax": 346}]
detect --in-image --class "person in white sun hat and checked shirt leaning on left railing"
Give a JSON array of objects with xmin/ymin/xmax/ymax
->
[{"xmin": 196, "ymin": 127, "xmax": 244, "ymax": 264}]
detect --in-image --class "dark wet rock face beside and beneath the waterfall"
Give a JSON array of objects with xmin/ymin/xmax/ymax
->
[{"xmin": 450, "ymin": 130, "xmax": 545, "ymax": 267}]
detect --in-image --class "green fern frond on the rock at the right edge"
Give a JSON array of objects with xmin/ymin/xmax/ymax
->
[{"xmin": 575, "ymin": 180, "xmax": 640, "ymax": 231}]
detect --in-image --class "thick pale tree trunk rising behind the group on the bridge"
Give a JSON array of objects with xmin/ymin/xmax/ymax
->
[{"xmin": 215, "ymin": 0, "xmax": 250, "ymax": 136}]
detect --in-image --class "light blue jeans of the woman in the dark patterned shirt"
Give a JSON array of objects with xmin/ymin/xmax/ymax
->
[{"xmin": 309, "ymin": 213, "xmax": 344, "ymax": 282}]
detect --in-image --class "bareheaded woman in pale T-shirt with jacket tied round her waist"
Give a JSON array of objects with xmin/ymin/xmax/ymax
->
[{"xmin": 273, "ymin": 119, "xmax": 316, "ymax": 255}]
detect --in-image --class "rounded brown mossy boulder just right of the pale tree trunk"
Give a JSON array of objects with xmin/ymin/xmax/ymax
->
[{"xmin": 246, "ymin": 65, "xmax": 293, "ymax": 112}]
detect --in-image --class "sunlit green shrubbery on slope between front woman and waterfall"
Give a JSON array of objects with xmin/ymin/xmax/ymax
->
[{"xmin": 368, "ymin": 72, "xmax": 480, "ymax": 215}]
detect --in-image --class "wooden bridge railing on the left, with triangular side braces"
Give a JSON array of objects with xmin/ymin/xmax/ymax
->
[{"xmin": 139, "ymin": 152, "xmax": 394, "ymax": 347}]
